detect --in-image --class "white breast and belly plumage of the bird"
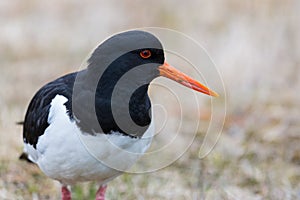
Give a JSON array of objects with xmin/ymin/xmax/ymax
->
[{"xmin": 25, "ymin": 95, "xmax": 154, "ymax": 185}]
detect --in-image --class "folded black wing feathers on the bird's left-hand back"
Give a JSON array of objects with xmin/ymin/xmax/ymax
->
[{"xmin": 23, "ymin": 73, "xmax": 77, "ymax": 148}]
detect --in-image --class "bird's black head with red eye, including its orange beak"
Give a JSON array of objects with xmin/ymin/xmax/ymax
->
[{"xmin": 88, "ymin": 30, "xmax": 218, "ymax": 96}]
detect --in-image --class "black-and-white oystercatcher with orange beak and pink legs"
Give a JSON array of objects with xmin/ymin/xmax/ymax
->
[{"xmin": 21, "ymin": 30, "xmax": 218, "ymax": 200}]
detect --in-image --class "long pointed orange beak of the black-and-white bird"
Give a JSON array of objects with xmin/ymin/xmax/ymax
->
[{"xmin": 158, "ymin": 62, "xmax": 219, "ymax": 97}]
